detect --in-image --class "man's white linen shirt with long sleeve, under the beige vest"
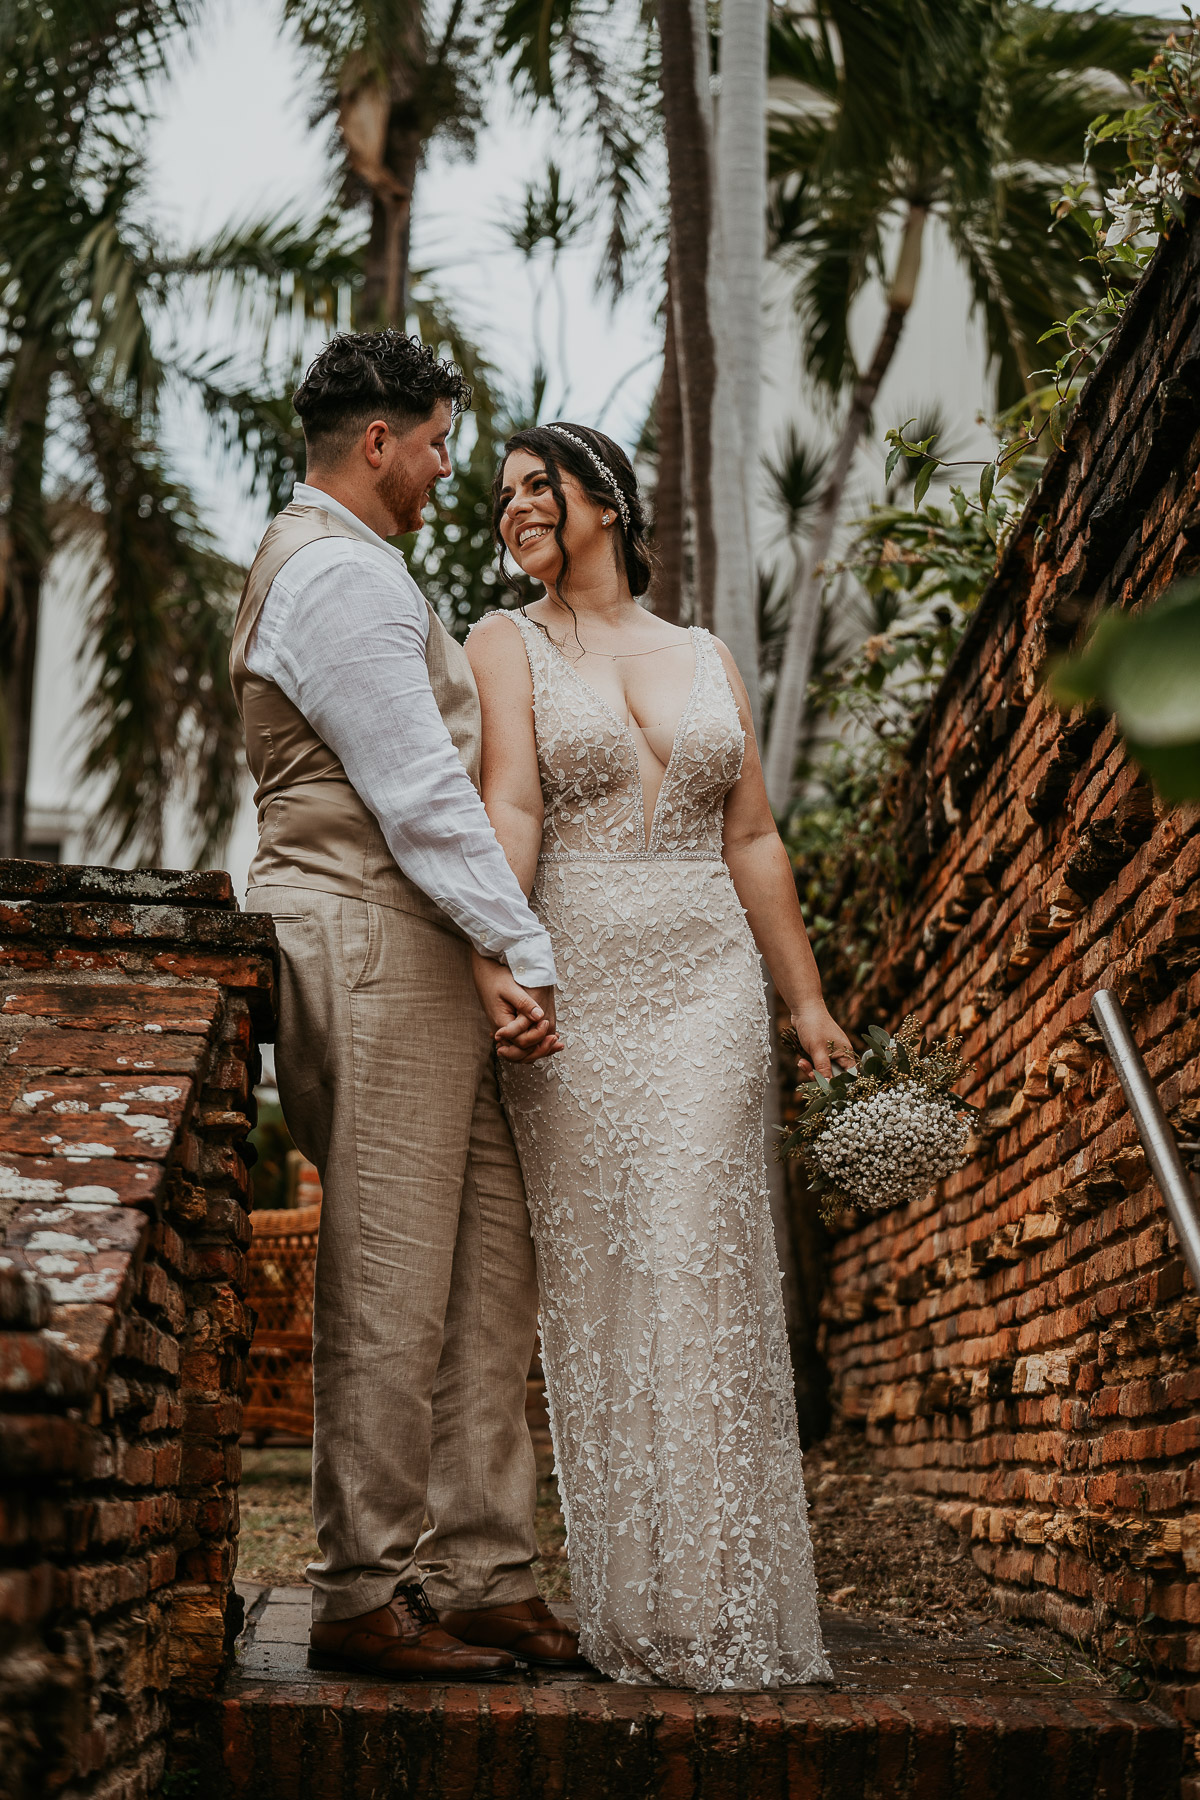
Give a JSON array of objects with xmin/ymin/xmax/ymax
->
[{"xmin": 246, "ymin": 481, "xmax": 556, "ymax": 988}]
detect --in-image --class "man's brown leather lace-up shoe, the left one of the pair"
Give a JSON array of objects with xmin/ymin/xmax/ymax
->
[{"xmin": 308, "ymin": 1582, "xmax": 516, "ymax": 1681}]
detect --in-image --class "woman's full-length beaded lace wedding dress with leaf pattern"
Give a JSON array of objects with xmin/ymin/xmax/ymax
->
[{"xmin": 500, "ymin": 614, "xmax": 829, "ymax": 1690}]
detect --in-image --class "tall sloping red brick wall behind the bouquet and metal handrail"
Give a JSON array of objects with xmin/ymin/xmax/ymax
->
[{"xmin": 824, "ymin": 204, "xmax": 1200, "ymax": 1796}]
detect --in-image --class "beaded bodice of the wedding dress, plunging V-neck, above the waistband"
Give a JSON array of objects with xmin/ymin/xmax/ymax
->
[{"xmin": 509, "ymin": 612, "xmax": 745, "ymax": 862}]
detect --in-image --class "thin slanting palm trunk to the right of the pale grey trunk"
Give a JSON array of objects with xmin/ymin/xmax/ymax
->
[{"xmin": 763, "ymin": 202, "xmax": 928, "ymax": 817}]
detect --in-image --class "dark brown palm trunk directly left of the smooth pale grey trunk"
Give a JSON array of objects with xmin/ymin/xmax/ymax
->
[{"xmin": 657, "ymin": 0, "xmax": 716, "ymax": 626}]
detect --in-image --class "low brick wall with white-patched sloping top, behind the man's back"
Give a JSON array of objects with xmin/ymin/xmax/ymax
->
[{"xmin": 0, "ymin": 862, "xmax": 273, "ymax": 1800}]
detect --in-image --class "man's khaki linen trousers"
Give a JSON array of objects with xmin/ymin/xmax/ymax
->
[{"xmin": 246, "ymin": 887, "xmax": 538, "ymax": 1620}]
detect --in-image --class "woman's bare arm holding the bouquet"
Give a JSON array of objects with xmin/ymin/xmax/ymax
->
[{"xmin": 718, "ymin": 639, "xmax": 855, "ymax": 1075}]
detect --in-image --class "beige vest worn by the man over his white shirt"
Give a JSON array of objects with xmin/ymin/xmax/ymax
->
[{"xmin": 228, "ymin": 502, "xmax": 480, "ymax": 931}]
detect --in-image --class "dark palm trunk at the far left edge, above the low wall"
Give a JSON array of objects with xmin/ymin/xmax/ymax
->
[{"xmin": 0, "ymin": 342, "xmax": 50, "ymax": 857}]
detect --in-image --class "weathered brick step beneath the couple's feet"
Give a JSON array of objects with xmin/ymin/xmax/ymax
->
[{"xmin": 201, "ymin": 1589, "xmax": 1180, "ymax": 1800}]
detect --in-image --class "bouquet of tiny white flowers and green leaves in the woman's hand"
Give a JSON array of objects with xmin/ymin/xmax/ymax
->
[{"xmin": 779, "ymin": 1013, "xmax": 977, "ymax": 1224}]
